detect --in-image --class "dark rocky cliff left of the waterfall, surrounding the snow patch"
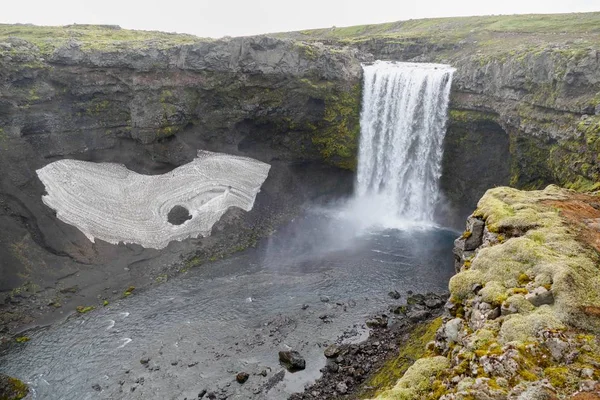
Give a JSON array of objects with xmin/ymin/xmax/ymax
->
[{"xmin": 0, "ymin": 27, "xmax": 361, "ymax": 332}]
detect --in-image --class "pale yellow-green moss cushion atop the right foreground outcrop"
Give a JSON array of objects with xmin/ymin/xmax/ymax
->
[{"xmin": 458, "ymin": 186, "xmax": 600, "ymax": 332}]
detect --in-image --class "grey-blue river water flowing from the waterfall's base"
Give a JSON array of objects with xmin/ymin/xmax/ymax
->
[{"xmin": 0, "ymin": 210, "xmax": 456, "ymax": 400}]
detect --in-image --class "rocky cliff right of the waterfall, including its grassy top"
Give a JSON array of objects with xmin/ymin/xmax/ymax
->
[{"xmin": 285, "ymin": 13, "xmax": 600, "ymax": 206}]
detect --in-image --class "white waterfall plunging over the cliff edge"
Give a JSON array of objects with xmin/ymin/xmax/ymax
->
[{"xmin": 356, "ymin": 61, "xmax": 454, "ymax": 222}]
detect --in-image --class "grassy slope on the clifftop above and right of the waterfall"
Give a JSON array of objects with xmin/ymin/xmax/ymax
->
[{"xmin": 274, "ymin": 12, "xmax": 600, "ymax": 56}]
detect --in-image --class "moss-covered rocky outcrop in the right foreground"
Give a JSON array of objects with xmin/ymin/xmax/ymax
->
[{"xmin": 370, "ymin": 186, "xmax": 600, "ymax": 400}]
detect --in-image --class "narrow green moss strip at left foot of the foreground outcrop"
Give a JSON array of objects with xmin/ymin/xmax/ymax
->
[{"xmin": 363, "ymin": 318, "xmax": 442, "ymax": 397}]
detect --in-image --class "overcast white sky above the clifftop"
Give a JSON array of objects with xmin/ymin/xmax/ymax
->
[{"xmin": 0, "ymin": 0, "xmax": 600, "ymax": 37}]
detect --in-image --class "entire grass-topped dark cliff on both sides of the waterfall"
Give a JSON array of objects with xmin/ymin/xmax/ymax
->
[{"xmin": 0, "ymin": 14, "xmax": 600, "ymax": 332}]
